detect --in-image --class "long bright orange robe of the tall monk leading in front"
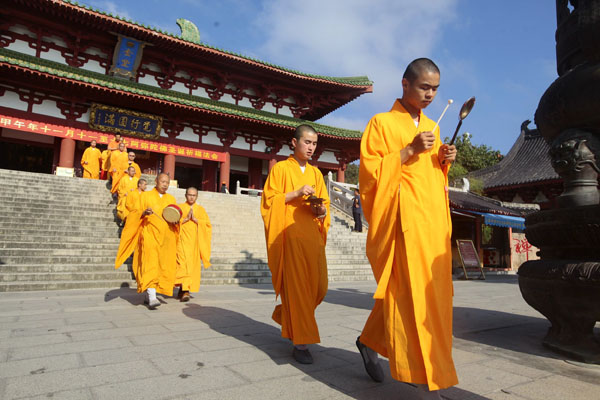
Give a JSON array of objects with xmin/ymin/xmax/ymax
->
[{"xmin": 359, "ymin": 101, "xmax": 458, "ymax": 390}]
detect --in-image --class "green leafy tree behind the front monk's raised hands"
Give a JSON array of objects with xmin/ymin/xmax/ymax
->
[{"xmin": 444, "ymin": 133, "xmax": 502, "ymax": 191}]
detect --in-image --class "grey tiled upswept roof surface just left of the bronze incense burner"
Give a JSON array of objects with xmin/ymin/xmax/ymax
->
[{"xmin": 469, "ymin": 130, "xmax": 561, "ymax": 190}]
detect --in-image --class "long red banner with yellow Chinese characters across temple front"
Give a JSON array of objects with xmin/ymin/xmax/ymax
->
[{"xmin": 0, "ymin": 114, "xmax": 225, "ymax": 162}]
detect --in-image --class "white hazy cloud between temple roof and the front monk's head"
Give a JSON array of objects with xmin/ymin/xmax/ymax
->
[{"xmin": 255, "ymin": 0, "xmax": 456, "ymax": 104}]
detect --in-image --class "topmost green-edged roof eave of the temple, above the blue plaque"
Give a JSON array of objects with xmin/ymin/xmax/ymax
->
[{"xmin": 21, "ymin": 0, "xmax": 373, "ymax": 93}]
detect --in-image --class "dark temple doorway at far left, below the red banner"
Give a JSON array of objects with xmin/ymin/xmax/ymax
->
[{"xmin": 0, "ymin": 141, "xmax": 54, "ymax": 174}]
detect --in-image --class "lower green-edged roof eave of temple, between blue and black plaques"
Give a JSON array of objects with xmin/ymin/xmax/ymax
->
[{"xmin": 0, "ymin": 49, "xmax": 362, "ymax": 140}]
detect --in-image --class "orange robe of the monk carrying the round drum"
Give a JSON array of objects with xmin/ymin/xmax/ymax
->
[{"xmin": 115, "ymin": 188, "xmax": 179, "ymax": 296}]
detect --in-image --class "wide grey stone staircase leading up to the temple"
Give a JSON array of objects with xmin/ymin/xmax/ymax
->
[{"xmin": 0, "ymin": 170, "xmax": 373, "ymax": 292}]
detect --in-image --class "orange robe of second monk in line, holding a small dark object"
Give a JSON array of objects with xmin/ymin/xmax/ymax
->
[{"xmin": 261, "ymin": 156, "xmax": 330, "ymax": 344}]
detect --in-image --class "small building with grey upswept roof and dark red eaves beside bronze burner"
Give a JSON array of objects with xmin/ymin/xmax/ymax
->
[{"xmin": 469, "ymin": 121, "xmax": 562, "ymax": 208}]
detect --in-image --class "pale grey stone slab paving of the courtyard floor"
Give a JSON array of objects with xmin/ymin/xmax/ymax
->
[{"xmin": 0, "ymin": 276, "xmax": 600, "ymax": 400}]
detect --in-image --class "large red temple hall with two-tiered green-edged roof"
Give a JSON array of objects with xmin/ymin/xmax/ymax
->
[{"xmin": 0, "ymin": 0, "xmax": 373, "ymax": 191}]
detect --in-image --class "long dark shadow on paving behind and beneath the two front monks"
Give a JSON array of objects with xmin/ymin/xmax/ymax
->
[{"xmin": 183, "ymin": 303, "xmax": 486, "ymax": 400}]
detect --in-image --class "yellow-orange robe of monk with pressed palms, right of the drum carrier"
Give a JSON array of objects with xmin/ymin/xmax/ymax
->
[{"xmin": 175, "ymin": 202, "xmax": 212, "ymax": 292}]
